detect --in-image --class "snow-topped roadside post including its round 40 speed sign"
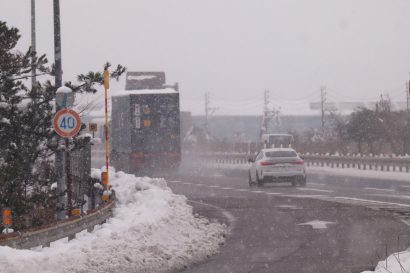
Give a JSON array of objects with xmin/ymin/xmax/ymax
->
[{"xmin": 53, "ymin": 87, "xmax": 81, "ymax": 216}]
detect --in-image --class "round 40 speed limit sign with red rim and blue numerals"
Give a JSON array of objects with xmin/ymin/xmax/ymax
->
[{"xmin": 53, "ymin": 109, "xmax": 81, "ymax": 137}]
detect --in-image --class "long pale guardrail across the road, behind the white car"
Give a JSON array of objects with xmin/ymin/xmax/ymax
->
[{"xmin": 190, "ymin": 153, "xmax": 410, "ymax": 172}]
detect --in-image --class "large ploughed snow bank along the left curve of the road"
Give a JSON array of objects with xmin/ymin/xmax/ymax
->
[{"xmin": 0, "ymin": 170, "xmax": 226, "ymax": 273}]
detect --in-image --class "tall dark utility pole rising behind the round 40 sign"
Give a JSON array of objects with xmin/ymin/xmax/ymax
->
[{"xmin": 53, "ymin": 0, "xmax": 68, "ymax": 220}]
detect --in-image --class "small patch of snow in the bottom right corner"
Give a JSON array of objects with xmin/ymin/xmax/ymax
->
[{"xmin": 362, "ymin": 249, "xmax": 410, "ymax": 273}]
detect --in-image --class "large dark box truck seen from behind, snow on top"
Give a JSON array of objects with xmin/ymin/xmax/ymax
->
[{"xmin": 111, "ymin": 72, "xmax": 181, "ymax": 174}]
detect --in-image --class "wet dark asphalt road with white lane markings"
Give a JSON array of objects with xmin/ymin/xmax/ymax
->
[{"xmin": 164, "ymin": 169, "xmax": 410, "ymax": 273}]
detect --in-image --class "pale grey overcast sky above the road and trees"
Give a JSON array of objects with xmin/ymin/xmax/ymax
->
[{"xmin": 0, "ymin": 0, "xmax": 410, "ymax": 114}]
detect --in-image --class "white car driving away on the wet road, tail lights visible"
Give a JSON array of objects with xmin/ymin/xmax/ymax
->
[{"xmin": 249, "ymin": 148, "xmax": 306, "ymax": 186}]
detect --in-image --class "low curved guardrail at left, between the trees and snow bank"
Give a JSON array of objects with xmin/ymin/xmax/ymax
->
[{"xmin": 0, "ymin": 194, "xmax": 115, "ymax": 249}]
